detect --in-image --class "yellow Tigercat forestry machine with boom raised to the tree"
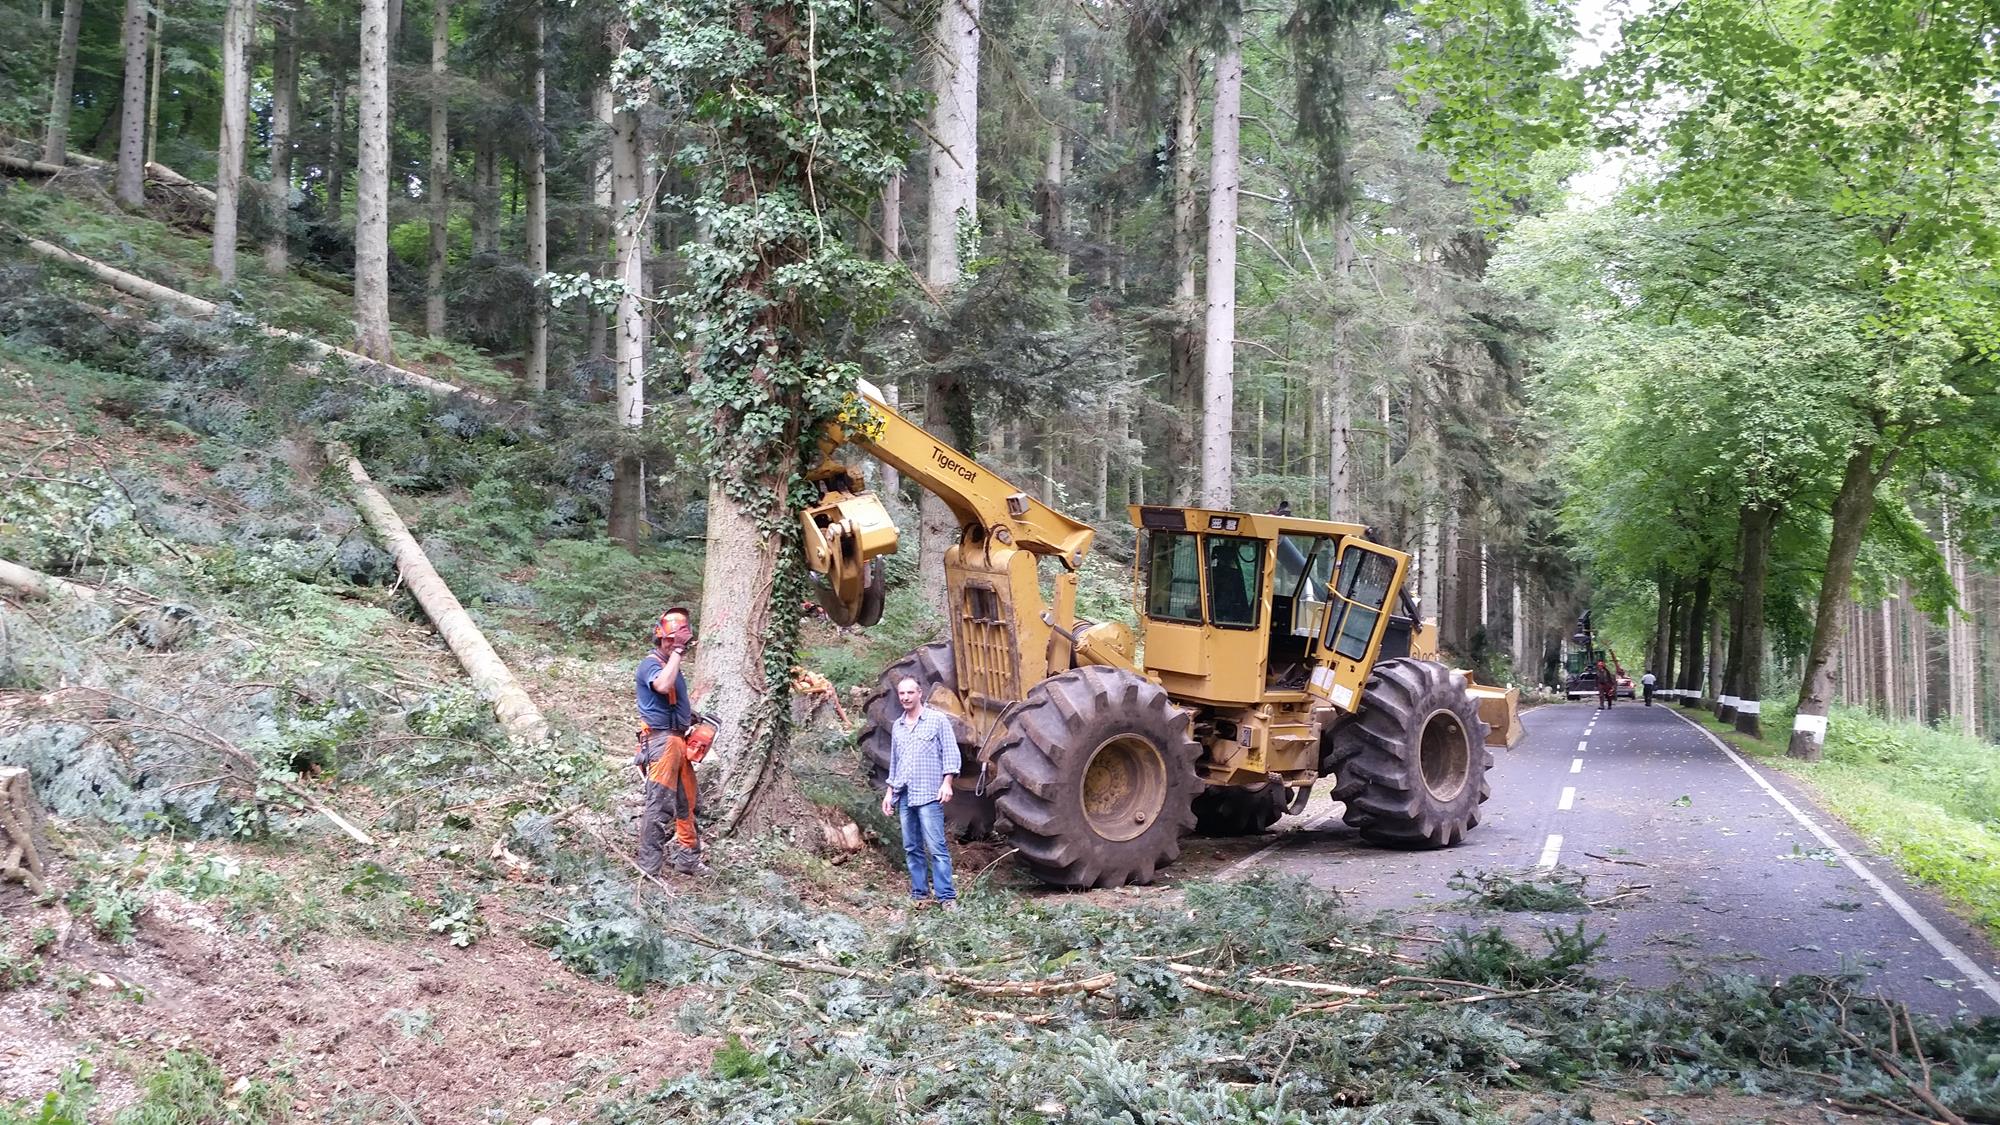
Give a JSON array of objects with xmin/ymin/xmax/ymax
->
[{"xmin": 800, "ymin": 382, "xmax": 1512, "ymax": 887}]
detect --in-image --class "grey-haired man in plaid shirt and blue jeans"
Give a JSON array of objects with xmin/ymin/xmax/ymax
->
[{"xmin": 882, "ymin": 679, "xmax": 960, "ymax": 909}]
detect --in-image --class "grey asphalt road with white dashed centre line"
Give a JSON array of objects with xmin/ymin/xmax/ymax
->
[{"xmin": 1188, "ymin": 701, "xmax": 2000, "ymax": 1017}]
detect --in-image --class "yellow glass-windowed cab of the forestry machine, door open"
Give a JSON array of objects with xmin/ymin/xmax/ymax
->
[{"xmin": 1132, "ymin": 506, "xmax": 1408, "ymax": 711}]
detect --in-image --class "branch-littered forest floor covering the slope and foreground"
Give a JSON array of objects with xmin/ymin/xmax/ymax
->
[{"xmin": 0, "ymin": 162, "xmax": 2000, "ymax": 1125}]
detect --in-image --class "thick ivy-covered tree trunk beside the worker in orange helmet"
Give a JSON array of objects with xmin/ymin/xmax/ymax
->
[{"xmin": 618, "ymin": 0, "xmax": 916, "ymax": 833}]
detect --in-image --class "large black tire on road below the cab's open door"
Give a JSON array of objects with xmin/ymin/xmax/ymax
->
[{"xmin": 1320, "ymin": 661, "xmax": 1494, "ymax": 849}]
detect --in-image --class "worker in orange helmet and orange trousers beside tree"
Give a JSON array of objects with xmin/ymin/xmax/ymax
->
[{"xmin": 632, "ymin": 607, "xmax": 716, "ymax": 875}]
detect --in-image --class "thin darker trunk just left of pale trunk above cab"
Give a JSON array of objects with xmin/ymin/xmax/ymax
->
[{"xmin": 1166, "ymin": 50, "xmax": 1202, "ymax": 504}]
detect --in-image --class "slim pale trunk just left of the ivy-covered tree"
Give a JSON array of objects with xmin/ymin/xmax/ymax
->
[{"xmin": 608, "ymin": 98, "xmax": 644, "ymax": 554}]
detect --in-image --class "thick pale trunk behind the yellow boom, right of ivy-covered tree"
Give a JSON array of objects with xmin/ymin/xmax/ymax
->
[{"xmin": 918, "ymin": 0, "xmax": 980, "ymax": 607}]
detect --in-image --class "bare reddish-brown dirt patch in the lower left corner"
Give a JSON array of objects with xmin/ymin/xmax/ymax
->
[{"xmin": 0, "ymin": 860, "xmax": 718, "ymax": 1121}]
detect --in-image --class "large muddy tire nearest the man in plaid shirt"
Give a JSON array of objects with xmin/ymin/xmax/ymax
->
[{"xmin": 994, "ymin": 665, "xmax": 1202, "ymax": 887}]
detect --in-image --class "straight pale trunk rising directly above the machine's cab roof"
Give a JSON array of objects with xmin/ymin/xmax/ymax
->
[{"xmin": 1202, "ymin": 26, "xmax": 1244, "ymax": 508}]
